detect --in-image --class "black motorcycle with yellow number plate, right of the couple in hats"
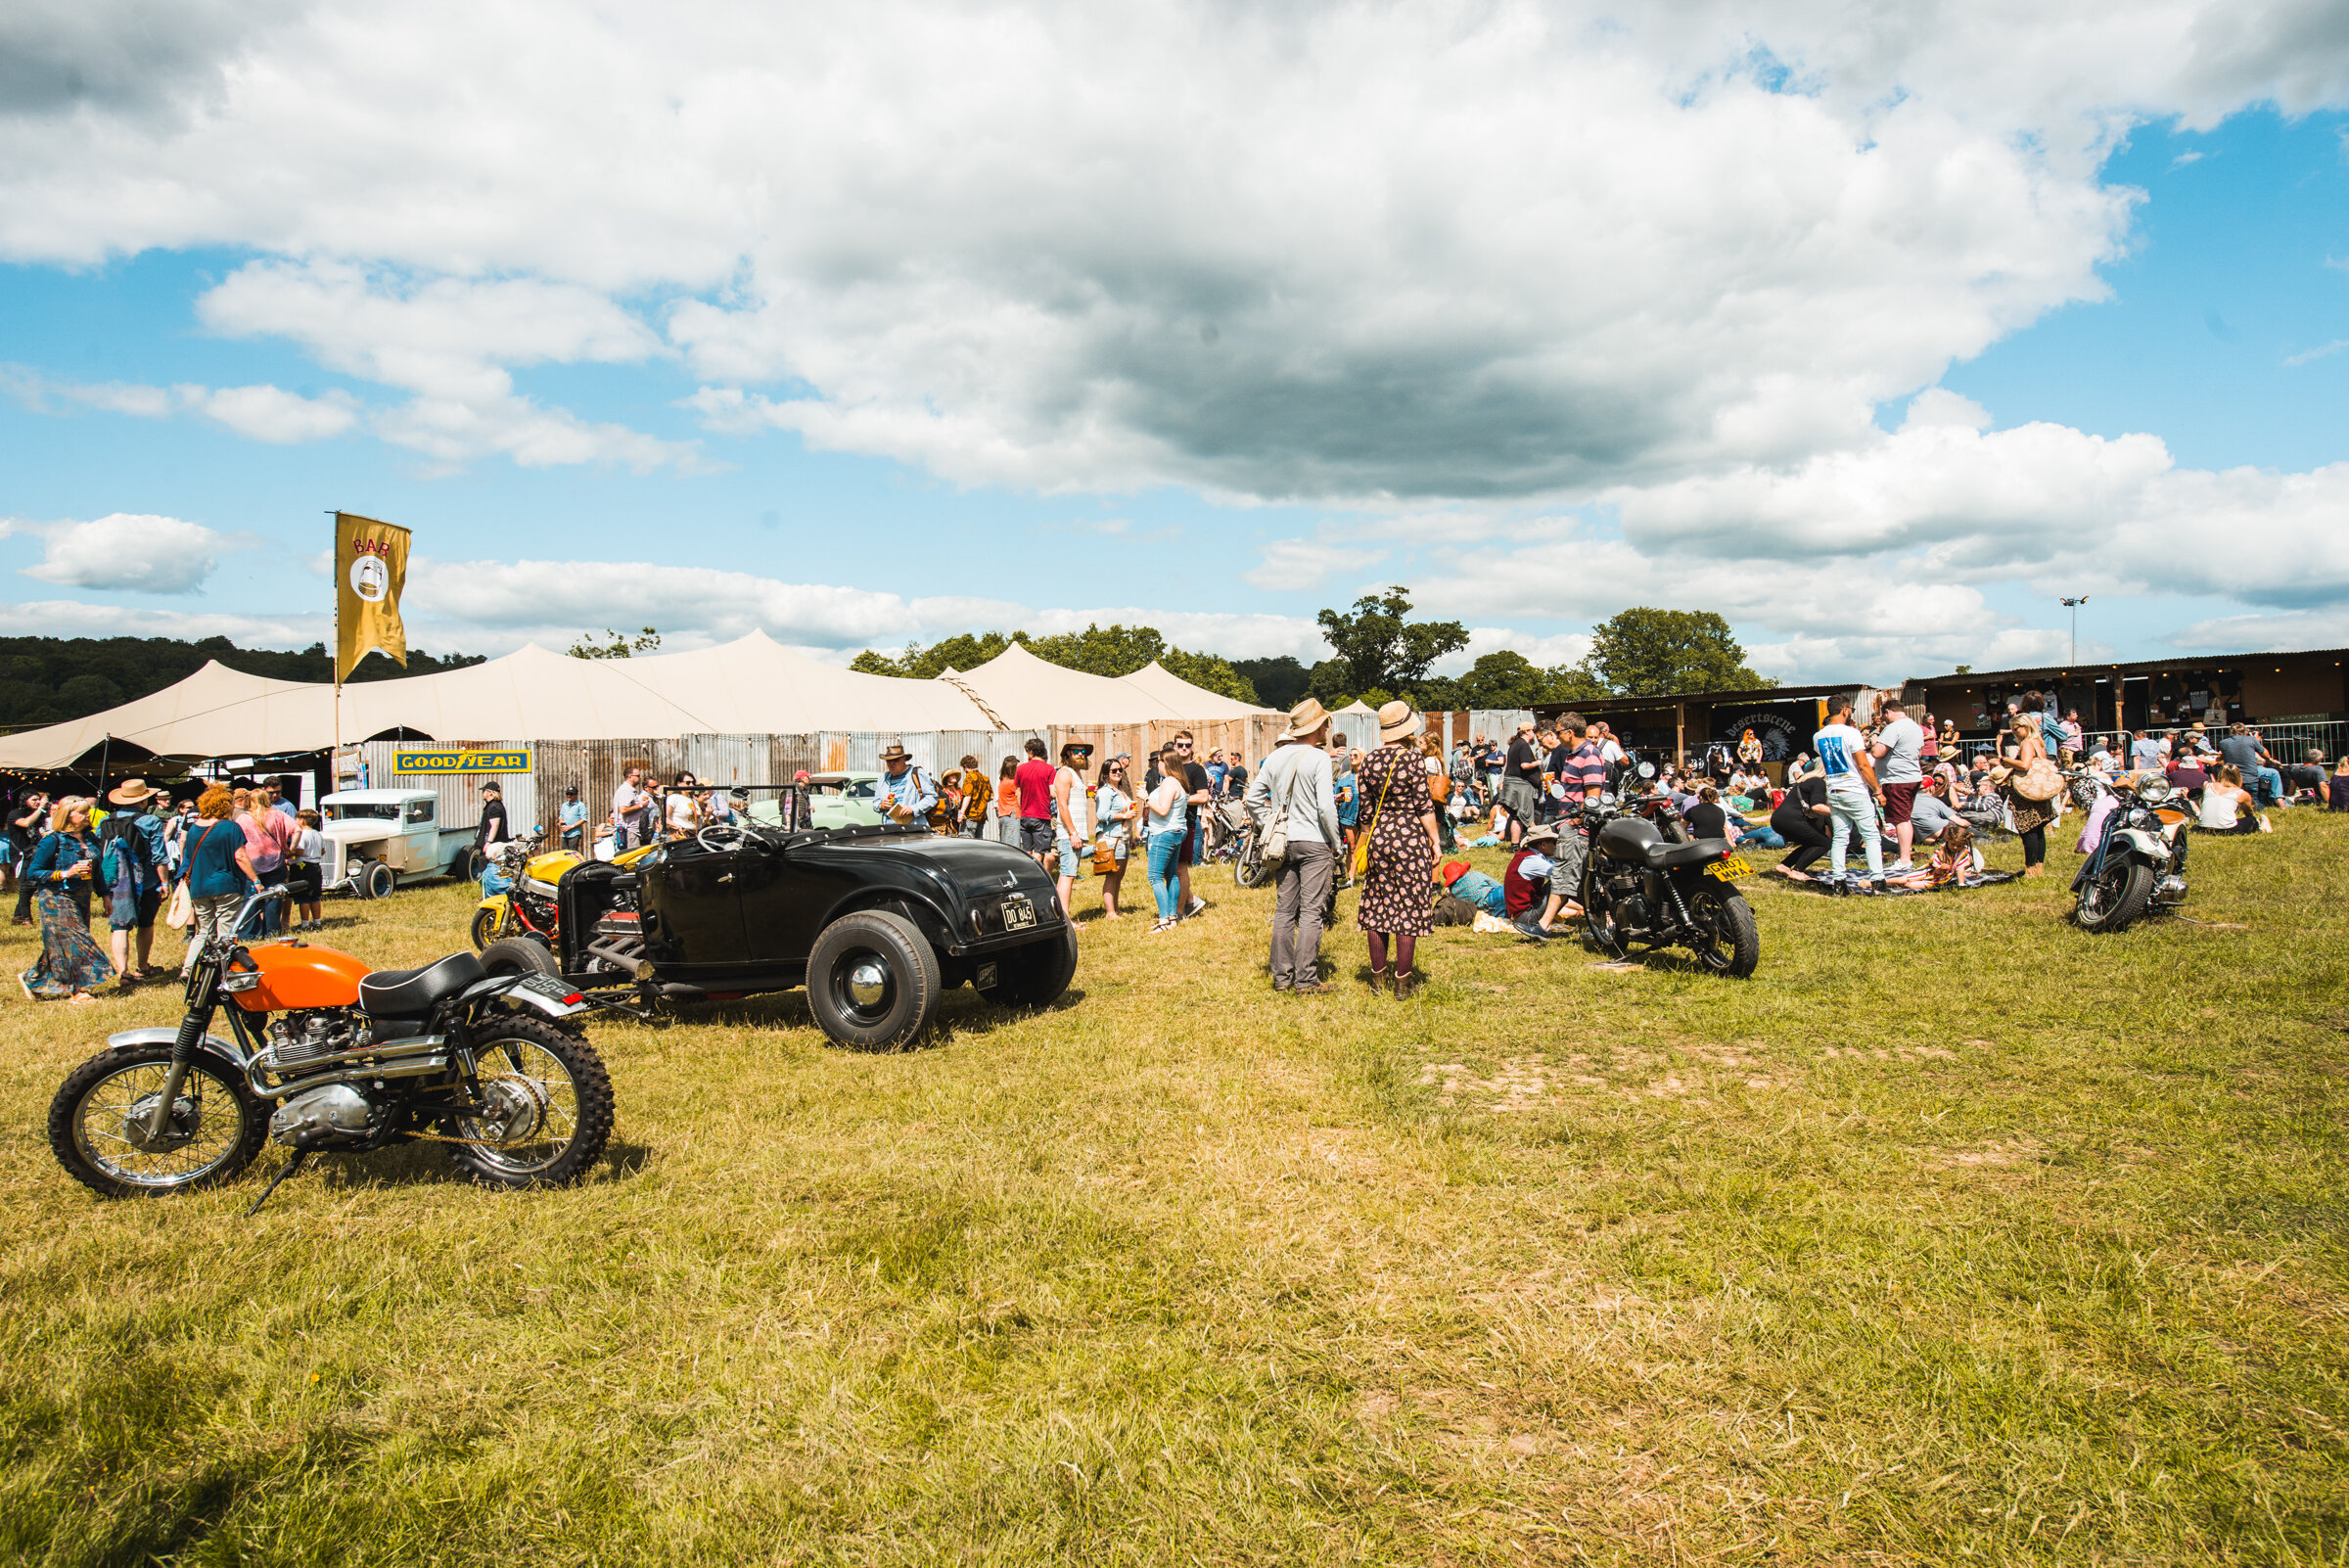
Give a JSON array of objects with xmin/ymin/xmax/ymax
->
[{"xmin": 1581, "ymin": 762, "xmax": 1762, "ymax": 979}]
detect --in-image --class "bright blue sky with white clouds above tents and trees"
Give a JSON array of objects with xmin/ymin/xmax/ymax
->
[{"xmin": 0, "ymin": 7, "xmax": 2349, "ymax": 678}]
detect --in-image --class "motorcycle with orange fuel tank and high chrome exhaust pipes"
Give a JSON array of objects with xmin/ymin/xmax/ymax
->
[{"xmin": 49, "ymin": 888, "xmax": 613, "ymax": 1209}]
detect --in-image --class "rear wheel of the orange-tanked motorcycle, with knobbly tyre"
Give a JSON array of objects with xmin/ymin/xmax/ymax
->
[{"xmin": 441, "ymin": 1016, "xmax": 611, "ymax": 1187}]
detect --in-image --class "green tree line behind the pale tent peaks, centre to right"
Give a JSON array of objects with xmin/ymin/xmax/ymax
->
[{"xmin": 851, "ymin": 587, "xmax": 1775, "ymax": 712}]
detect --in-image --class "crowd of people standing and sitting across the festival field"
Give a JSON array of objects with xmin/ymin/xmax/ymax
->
[{"xmin": 5, "ymin": 692, "xmax": 2349, "ymax": 1002}]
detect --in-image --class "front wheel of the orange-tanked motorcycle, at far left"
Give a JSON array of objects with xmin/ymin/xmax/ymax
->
[{"xmin": 49, "ymin": 1042, "xmax": 268, "ymax": 1197}]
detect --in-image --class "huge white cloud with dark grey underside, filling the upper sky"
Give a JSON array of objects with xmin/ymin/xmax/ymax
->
[{"xmin": 0, "ymin": 0, "xmax": 2349, "ymax": 497}]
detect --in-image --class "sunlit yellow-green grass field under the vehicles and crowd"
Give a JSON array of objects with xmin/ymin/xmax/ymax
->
[{"xmin": 0, "ymin": 809, "xmax": 2349, "ymax": 1566}]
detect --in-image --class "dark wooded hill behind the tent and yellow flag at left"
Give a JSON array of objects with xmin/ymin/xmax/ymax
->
[{"xmin": 0, "ymin": 636, "xmax": 484, "ymax": 730}]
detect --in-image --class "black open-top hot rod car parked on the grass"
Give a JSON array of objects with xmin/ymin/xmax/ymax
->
[{"xmin": 482, "ymin": 786, "xmax": 1076, "ymax": 1049}]
